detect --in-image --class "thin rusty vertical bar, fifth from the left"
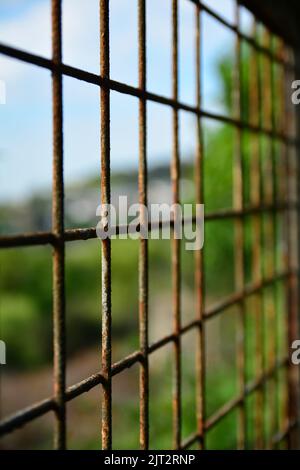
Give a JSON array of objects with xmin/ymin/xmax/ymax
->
[{"xmin": 195, "ymin": 5, "xmax": 205, "ymax": 449}]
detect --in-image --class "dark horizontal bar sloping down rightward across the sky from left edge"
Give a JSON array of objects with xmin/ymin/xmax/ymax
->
[{"xmin": 0, "ymin": 44, "xmax": 299, "ymax": 146}]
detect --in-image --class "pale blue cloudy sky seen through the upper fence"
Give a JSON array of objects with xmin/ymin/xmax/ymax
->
[{"xmin": 0, "ymin": 0, "xmax": 253, "ymax": 201}]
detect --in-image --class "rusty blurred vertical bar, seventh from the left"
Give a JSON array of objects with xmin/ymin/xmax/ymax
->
[{"xmin": 250, "ymin": 20, "xmax": 263, "ymax": 449}]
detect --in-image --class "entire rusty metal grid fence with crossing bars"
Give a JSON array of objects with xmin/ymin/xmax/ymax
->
[{"xmin": 0, "ymin": 0, "xmax": 300, "ymax": 449}]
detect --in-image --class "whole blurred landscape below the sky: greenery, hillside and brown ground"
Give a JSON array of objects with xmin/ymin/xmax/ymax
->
[{"xmin": 0, "ymin": 47, "xmax": 285, "ymax": 449}]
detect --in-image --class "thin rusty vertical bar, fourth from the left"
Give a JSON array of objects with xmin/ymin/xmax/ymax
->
[{"xmin": 171, "ymin": 0, "xmax": 181, "ymax": 449}]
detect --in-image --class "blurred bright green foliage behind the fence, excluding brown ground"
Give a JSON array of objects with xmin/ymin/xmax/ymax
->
[{"xmin": 0, "ymin": 46, "xmax": 283, "ymax": 449}]
